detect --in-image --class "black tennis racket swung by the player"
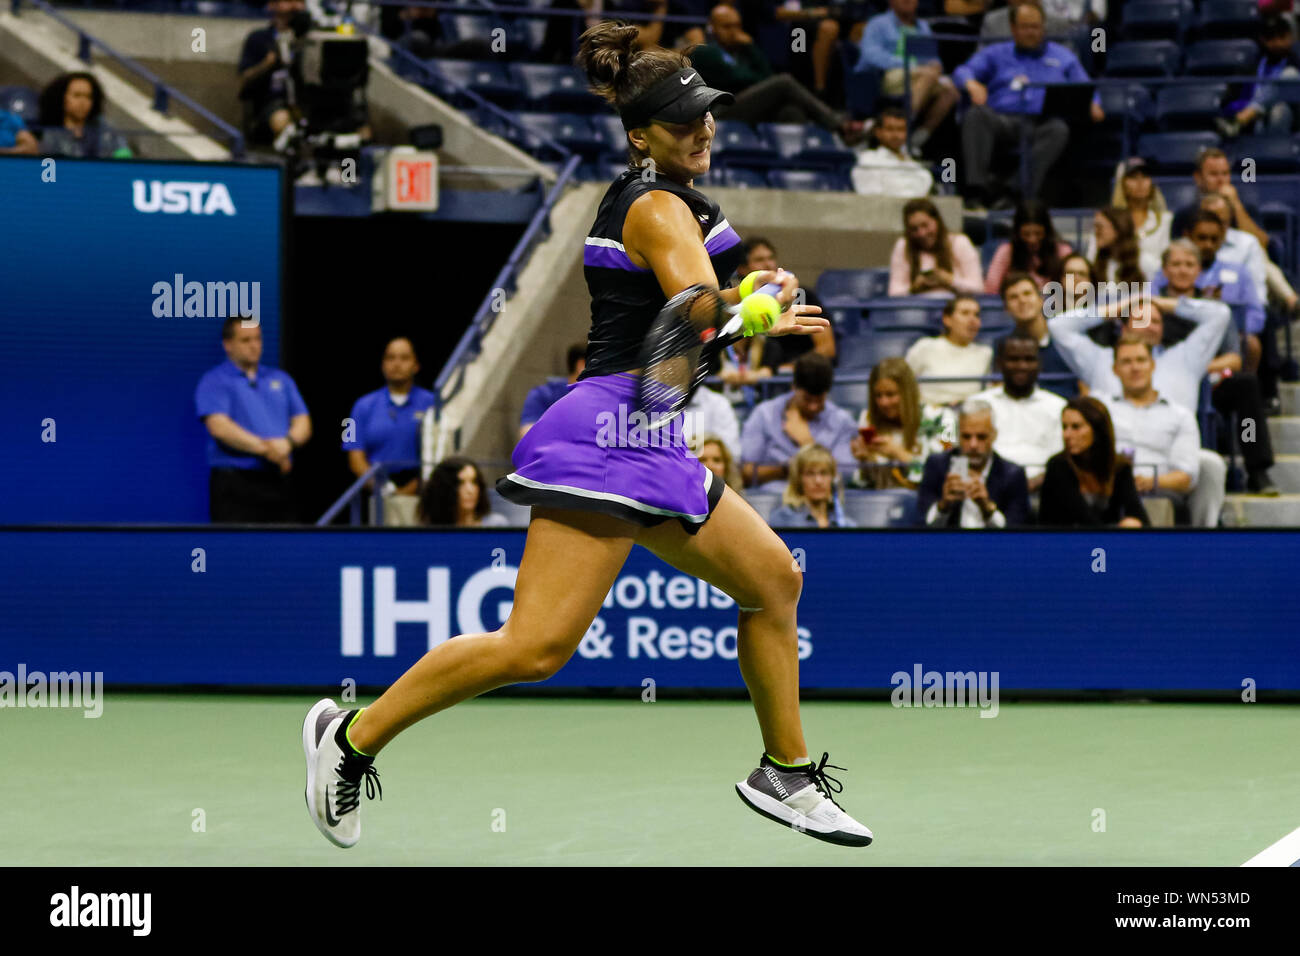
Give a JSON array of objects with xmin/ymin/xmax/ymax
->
[{"xmin": 637, "ymin": 282, "xmax": 781, "ymax": 429}]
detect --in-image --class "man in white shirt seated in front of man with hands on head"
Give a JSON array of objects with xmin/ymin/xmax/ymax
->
[{"xmin": 1097, "ymin": 333, "xmax": 1223, "ymax": 528}]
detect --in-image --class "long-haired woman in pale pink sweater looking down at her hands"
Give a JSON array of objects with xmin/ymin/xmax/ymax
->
[{"xmin": 889, "ymin": 199, "xmax": 982, "ymax": 297}]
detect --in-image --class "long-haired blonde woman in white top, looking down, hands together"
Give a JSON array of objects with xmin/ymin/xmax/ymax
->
[{"xmin": 850, "ymin": 358, "xmax": 957, "ymax": 489}]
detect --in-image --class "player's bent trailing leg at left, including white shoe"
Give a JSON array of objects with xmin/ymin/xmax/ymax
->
[{"xmin": 303, "ymin": 507, "xmax": 638, "ymax": 847}]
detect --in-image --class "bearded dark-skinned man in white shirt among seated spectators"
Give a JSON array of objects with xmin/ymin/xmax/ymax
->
[{"xmin": 970, "ymin": 332, "xmax": 1065, "ymax": 492}]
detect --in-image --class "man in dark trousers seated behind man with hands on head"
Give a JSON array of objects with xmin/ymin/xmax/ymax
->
[{"xmin": 1157, "ymin": 239, "xmax": 1278, "ymax": 494}]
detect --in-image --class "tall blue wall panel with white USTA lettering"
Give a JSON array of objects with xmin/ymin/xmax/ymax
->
[{"xmin": 0, "ymin": 156, "xmax": 282, "ymax": 523}]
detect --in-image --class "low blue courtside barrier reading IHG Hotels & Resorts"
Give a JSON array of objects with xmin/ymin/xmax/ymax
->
[{"xmin": 0, "ymin": 527, "xmax": 1300, "ymax": 692}]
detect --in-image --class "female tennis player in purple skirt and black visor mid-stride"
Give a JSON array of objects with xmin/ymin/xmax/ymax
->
[{"xmin": 303, "ymin": 22, "xmax": 871, "ymax": 847}]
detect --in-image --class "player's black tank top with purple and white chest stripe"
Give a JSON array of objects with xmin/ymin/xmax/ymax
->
[{"xmin": 579, "ymin": 169, "xmax": 745, "ymax": 378}]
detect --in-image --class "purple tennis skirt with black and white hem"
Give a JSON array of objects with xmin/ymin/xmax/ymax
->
[{"xmin": 497, "ymin": 372, "xmax": 724, "ymax": 535}]
